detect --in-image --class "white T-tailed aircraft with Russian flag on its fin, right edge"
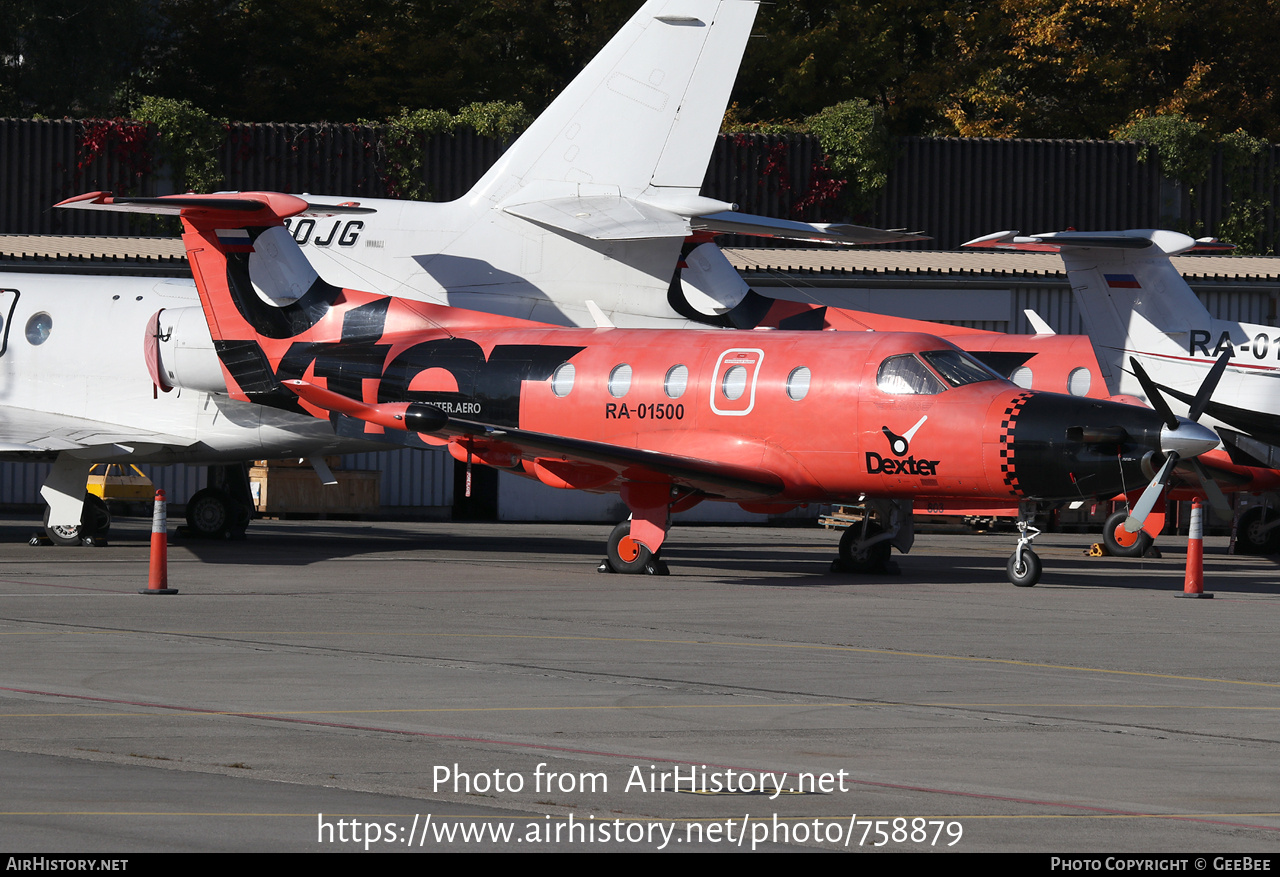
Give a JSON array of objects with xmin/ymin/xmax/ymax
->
[{"xmin": 964, "ymin": 229, "xmax": 1280, "ymax": 552}]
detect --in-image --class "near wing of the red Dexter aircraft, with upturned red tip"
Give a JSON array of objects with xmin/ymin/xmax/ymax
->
[{"xmin": 283, "ymin": 380, "xmax": 786, "ymax": 499}]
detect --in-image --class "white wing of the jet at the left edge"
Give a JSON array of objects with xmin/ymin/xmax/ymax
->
[{"xmin": 0, "ymin": 406, "xmax": 195, "ymax": 460}]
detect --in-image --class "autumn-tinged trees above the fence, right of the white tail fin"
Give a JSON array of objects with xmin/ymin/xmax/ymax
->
[{"xmin": 735, "ymin": 0, "xmax": 1280, "ymax": 141}]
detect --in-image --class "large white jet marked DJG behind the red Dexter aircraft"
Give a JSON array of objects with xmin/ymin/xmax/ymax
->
[{"xmin": 0, "ymin": 0, "xmax": 919, "ymax": 543}]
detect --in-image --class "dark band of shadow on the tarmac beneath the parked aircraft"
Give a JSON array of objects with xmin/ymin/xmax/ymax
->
[{"xmin": 10, "ymin": 519, "xmax": 1280, "ymax": 594}]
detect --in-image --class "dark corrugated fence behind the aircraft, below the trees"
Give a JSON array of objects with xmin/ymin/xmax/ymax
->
[{"xmin": 0, "ymin": 119, "xmax": 1280, "ymax": 250}]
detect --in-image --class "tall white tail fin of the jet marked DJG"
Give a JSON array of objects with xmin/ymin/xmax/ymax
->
[{"xmin": 467, "ymin": 0, "xmax": 758, "ymax": 205}]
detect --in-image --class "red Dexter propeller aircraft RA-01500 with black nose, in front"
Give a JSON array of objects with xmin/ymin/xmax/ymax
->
[{"xmin": 64, "ymin": 192, "xmax": 1217, "ymax": 585}]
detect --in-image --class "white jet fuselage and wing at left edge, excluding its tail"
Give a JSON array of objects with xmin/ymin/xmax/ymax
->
[{"xmin": 0, "ymin": 274, "xmax": 367, "ymax": 463}]
